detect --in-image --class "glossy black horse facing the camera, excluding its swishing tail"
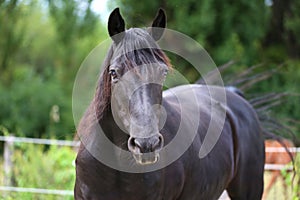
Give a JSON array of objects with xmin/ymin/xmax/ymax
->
[{"xmin": 74, "ymin": 8, "xmax": 265, "ymax": 200}]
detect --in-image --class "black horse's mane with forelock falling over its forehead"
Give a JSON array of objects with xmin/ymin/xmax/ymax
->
[{"xmin": 78, "ymin": 28, "xmax": 171, "ymax": 138}]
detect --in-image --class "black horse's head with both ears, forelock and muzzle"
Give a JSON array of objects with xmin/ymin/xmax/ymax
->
[{"xmin": 107, "ymin": 8, "xmax": 170, "ymax": 164}]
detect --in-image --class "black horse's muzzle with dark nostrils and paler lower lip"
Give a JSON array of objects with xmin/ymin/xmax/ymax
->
[{"xmin": 128, "ymin": 134, "xmax": 164, "ymax": 165}]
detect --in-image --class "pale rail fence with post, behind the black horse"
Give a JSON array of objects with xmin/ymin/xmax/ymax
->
[{"xmin": 0, "ymin": 136, "xmax": 300, "ymax": 196}]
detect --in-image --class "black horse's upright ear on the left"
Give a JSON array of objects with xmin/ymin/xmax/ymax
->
[{"xmin": 108, "ymin": 8, "xmax": 125, "ymax": 43}]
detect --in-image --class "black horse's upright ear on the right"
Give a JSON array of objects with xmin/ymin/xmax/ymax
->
[{"xmin": 150, "ymin": 8, "xmax": 167, "ymax": 41}]
